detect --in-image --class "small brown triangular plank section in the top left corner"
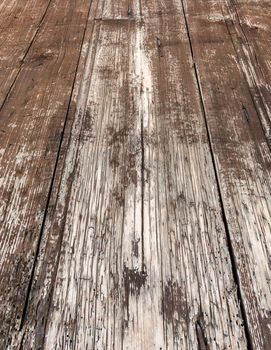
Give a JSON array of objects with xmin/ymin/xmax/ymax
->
[{"xmin": 0, "ymin": 0, "xmax": 50, "ymax": 108}]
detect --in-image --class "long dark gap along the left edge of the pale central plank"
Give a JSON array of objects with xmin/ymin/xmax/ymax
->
[{"xmin": 19, "ymin": 1, "xmax": 92, "ymax": 331}]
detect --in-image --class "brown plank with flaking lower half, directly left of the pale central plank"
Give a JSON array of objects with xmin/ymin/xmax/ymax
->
[{"xmin": 0, "ymin": 0, "xmax": 92, "ymax": 349}]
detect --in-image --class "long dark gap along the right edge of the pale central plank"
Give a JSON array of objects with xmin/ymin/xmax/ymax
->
[{"xmin": 180, "ymin": 0, "xmax": 253, "ymax": 350}]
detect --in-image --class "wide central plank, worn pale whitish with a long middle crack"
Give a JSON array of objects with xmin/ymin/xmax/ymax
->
[{"xmin": 14, "ymin": 0, "xmax": 251, "ymax": 350}]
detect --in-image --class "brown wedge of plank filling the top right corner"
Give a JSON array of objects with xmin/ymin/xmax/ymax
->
[{"xmin": 223, "ymin": 0, "xmax": 271, "ymax": 146}]
